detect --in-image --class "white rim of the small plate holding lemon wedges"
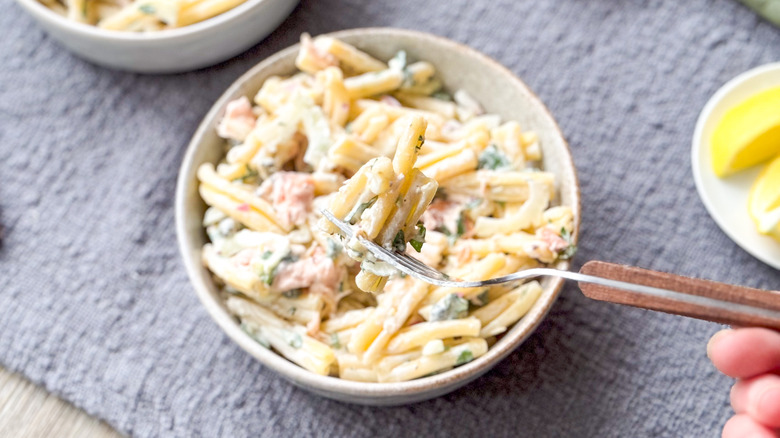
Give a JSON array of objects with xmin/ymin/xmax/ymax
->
[{"xmin": 691, "ymin": 62, "xmax": 780, "ymax": 269}]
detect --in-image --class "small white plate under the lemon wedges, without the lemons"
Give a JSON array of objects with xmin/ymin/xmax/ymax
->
[{"xmin": 691, "ymin": 63, "xmax": 780, "ymax": 269}]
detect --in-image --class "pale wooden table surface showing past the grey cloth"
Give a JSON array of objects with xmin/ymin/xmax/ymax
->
[{"xmin": 0, "ymin": 367, "xmax": 122, "ymax": 438}]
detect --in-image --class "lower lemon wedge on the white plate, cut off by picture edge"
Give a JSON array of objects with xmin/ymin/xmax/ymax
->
[{"xmin": 748, "ymin": 155, "xmax": 780, "ymax": 242}]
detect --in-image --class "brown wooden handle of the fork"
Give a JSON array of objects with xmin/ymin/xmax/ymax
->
[{"xmin": 579, "ymin": 261, "xmax": 780, "ymax": 330}]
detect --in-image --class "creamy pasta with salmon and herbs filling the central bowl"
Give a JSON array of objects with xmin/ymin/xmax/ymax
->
[{"xmin": 197, "ymin": 35, "xmax": 574, "ymax": 382}]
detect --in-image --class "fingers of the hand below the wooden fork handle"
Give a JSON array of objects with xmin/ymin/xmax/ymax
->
[{"xmin": 707, "ymin": 328, "xmax": 780, "ymax": 438}]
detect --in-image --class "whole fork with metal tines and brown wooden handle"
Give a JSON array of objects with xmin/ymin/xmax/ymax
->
[{"xmin": 321, "ymin": 210, "xmax": 780, "ymax": 330}]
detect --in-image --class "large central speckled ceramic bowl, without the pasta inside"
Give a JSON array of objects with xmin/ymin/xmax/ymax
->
[{"xmin": 176, "ymin": 28, "xmax": 580, "ymax": 405}]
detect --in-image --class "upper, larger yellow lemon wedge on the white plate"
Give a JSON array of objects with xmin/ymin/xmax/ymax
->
[{"xmin": 711, "ymin": 87, "xmax": 780, "ymax": 178}]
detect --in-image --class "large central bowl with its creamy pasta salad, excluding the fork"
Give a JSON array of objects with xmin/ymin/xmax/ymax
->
[{"xmin": 177, "ymin": 29, "xmax": 579, "ymax": 404}]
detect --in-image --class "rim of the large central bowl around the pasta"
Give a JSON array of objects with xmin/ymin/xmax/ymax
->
[{"xmin": 175, "ymin": 27, "xmax": 581, "ymax": 402}]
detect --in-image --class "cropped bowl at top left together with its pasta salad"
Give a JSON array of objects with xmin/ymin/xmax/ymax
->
[{"xmin": 12, "ymin": 0, "xmax": 298, "ymax": 73}]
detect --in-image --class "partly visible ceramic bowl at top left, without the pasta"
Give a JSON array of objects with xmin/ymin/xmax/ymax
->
[{"xmin": 12, "ymin": 0, "xmax": 298, "ymax": 73}]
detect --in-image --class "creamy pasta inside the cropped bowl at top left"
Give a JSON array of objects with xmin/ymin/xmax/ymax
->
[{"xmin": 39, "ymin": 0, "xmax": 246, "ymax": 32}]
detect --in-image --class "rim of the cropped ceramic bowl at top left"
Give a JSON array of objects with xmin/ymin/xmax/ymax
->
[{"xmin": 16, "ymin": 0, "xmax": 278, "ymax": 43}]
